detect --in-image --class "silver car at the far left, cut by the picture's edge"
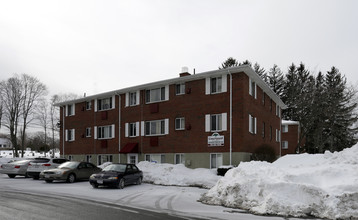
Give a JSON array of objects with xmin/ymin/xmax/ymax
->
[{"xmin": 0, "ymin": 158, "xmax": 39, "ymax": 178}]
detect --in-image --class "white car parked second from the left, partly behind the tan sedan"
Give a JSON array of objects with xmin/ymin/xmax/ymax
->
[{"xmin": 27, "ymin": 158, "xmax": 68, "ymax": 179}]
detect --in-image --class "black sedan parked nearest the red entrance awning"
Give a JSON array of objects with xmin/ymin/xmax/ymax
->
[{"xmin": 89, "ymin": 163, "xmax": 143, "ymax": 189}]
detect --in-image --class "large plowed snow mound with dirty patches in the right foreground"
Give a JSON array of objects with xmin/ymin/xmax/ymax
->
[{"xmin": 200, "ymin": 145, "xmax": 358, "ymax": 219}]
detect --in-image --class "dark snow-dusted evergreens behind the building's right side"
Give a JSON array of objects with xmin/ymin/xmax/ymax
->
[{"xmin": 219, "ymin": 57, "xmax": 358, "ymax": 153}]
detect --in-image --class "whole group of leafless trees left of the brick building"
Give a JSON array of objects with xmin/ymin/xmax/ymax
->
[{"xmin": 0, "ymin": 74, "xmax": 77, "ymax": 157}]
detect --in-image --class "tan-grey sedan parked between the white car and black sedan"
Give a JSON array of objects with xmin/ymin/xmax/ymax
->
[{"xmin": 40, "ymin": 161, "xmax": 101, "ymax": 183}]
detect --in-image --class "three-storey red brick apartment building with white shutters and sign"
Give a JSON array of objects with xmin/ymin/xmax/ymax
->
[{"xmin": 57, "ymin": 66, "xmax": 285, "ymax": 168}]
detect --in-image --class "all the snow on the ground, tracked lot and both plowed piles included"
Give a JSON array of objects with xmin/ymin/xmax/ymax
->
[{"xmin": 0, "ymin": 145, "xmax": 358, "ymax": 219}]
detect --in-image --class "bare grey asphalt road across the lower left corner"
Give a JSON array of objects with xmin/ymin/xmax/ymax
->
[{"xmin": 0, "ymin": 190, "xmax": 200, "ymax": 220}]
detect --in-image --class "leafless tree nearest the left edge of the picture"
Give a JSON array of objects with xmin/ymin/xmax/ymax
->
[{"xmin": 0, "ymin": 75, "xmax": 23, "ymax": 157}]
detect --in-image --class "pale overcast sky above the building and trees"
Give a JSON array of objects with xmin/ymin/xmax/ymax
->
[{"xmin": 0, "ymin": 0, "xmax": 358, "ymax": 96}]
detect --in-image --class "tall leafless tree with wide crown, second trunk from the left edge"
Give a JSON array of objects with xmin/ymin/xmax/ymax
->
[{"xmin": 21, "ymin": 74, "xmax": 47, "ymax": 157}]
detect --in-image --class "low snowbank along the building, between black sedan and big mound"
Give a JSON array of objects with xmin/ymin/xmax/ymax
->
[{"xmin": 137, "ymin": 161, "xmax": 221, "ymax": 189}]
